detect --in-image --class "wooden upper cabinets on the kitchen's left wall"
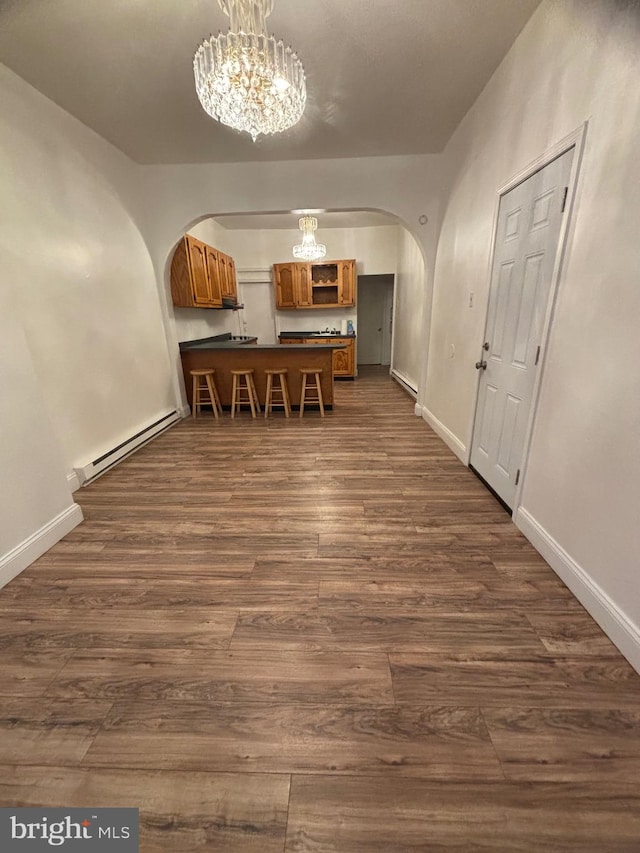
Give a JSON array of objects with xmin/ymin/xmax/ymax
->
[{"xmin": 171, "ymin": 234, "xmax": 237, "ymax": 308}]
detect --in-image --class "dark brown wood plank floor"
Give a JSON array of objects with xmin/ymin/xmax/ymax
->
[{"xmin": 0, "ymin": 362, "xmax": 640, "ymax": 853}]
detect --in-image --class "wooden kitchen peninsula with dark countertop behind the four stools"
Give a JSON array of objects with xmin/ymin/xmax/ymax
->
[{"xmin": 180, "ymin": 334, "xmax": 345, "ymax": 409}]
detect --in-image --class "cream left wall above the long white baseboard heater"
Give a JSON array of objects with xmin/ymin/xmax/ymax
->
[{"xmin": 0, "ymin": 66, "xmax": 175, "ymax": 480}]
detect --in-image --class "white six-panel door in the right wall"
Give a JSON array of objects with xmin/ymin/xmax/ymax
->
[{"xmin": 470, "ymin": 149, "xmax": 574, "ymax": 507}]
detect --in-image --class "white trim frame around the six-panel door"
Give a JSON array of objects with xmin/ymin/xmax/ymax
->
[{"xmin": 464, "ymin": 121, "xmax": 589, "ymax": 518}]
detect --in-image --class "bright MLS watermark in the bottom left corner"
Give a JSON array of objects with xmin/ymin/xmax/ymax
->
[{"xmin": 0, "ymin": 808, "xmax": 139, "ymax": 853}]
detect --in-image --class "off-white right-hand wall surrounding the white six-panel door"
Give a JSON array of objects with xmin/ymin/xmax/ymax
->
[{"xmin": 426, "ymin": 0, "xmax": 640, "ymax": 669}]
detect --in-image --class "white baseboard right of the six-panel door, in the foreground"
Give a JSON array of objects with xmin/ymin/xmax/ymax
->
[{"xmin": 513, "ymin": 507, "xmax": 640, "ymax": 673}]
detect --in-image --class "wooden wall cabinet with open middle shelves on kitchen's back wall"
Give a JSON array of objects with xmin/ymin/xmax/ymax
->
[{"xmin": 273, "ymin": 259, "xmax": 356, "ymax": 310}]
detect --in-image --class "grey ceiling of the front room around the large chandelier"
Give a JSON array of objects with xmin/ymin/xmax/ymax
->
[{"xmin": 0, "ymin": 0, "xmax": 540, "ymax": 163}]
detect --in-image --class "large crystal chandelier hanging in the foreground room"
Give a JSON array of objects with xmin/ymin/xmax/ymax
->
[{"xmin": 193, "ymin": 0, "xmax": 307, "ymax": 142}]
